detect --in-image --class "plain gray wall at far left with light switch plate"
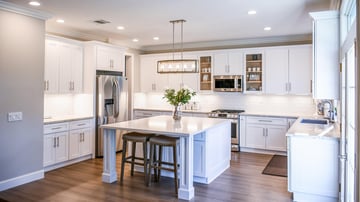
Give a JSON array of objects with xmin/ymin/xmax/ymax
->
[{"xmin": 0, "ymin": 5, "xmax": 45, "ymax": 188}]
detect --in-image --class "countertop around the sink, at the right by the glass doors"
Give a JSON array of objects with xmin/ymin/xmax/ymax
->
[{"xmin": 286, "ymin": 117, "xmax": 340, "ymax": 139}]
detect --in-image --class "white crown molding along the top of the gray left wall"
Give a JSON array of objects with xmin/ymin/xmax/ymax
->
[{"xmin": 0, "ymin": 0, "xmax": 51, "ymax": 20}]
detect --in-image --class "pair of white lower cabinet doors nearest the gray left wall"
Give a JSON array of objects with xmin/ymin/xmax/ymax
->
[{"xmin": 43, "ymin": 132, "xmax": 69, "ymax": 167}]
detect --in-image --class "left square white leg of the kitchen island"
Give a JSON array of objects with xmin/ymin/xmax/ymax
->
[{"xmin": 102, "ymin": 129, "xmax": 117, "ymax": 183}]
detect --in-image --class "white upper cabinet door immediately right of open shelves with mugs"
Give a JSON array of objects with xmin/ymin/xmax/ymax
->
[{"xmin": 265, "ymin": 48, "xmax": 288, "ymax": 94}]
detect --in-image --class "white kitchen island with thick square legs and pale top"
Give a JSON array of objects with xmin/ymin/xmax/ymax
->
[{"xmin": 101, "ymin": 116, "xmax": 231, "ymax": 200}]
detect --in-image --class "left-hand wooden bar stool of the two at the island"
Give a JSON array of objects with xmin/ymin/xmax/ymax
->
[{"xmin": 120, "ymin": 132, "xmax": 154, "ymax": 185}]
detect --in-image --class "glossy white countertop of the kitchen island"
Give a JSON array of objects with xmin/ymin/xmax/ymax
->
[{"xmin": 101, "ymin": 115, "xmax": 231, "ymax": 136}]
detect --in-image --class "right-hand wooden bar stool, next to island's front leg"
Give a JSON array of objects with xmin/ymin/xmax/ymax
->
[{"xmin": 147, "ymin": 135, "xmax": 180, "ymax": 195}]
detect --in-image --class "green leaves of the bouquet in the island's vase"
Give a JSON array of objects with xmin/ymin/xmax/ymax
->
[{"xmin": 163, "ymin": 88, "xmax": 196, "ymax": 106}]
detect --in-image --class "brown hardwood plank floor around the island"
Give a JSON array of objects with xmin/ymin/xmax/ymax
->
[{"xmin": 0, "ymin": 152, "xmax": 292, "ymax": 202}]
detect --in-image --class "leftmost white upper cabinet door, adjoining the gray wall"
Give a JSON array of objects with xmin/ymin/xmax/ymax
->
[{"xmin": 44, "ymin": 40, "xmax": 59, "ymax": 93}]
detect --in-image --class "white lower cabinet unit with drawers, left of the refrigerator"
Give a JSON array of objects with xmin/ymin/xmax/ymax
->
[{"xmin": 43, "ymin": 119, "xmax": 94, "ymax": 171}]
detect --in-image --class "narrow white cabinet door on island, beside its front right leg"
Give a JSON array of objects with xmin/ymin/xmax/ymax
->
[{"xmin": 194, "ymin": 141, "xmax": 205, "ymax": 177}]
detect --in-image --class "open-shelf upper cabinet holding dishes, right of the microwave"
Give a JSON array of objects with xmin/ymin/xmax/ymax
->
[{"xmin": 244, "ymin": 50, "xmax": 264, "ymax": 93}]
